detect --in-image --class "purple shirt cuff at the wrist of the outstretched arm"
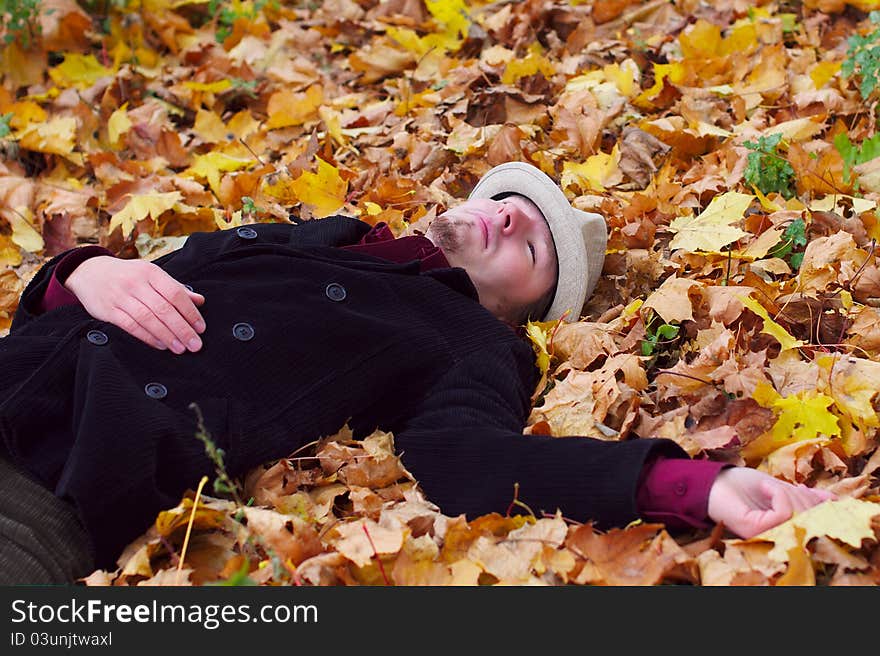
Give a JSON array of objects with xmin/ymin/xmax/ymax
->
[{"xmin": 636, "ymin": 457, "xmax": 732, "ymax": 528}]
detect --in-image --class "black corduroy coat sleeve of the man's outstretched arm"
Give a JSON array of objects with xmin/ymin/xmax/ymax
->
[{"xmin": 395, "ymin": 345, "xmax": 687, "ymax": 528}]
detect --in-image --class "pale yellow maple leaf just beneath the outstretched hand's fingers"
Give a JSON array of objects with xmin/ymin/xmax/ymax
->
[{"xmin": 746, "ymin": 498, "xmax": 880, "ymax": 562}]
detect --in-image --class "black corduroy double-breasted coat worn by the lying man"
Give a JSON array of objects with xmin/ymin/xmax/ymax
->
[{"xmin": 0, "ymin": 217, "xmax": 683, "ymax": 566}]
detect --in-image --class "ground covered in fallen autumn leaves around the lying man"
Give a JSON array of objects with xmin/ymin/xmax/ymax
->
[{"xmin": 0, "ymin": 0, "xmax": 880, "ymax": 585}]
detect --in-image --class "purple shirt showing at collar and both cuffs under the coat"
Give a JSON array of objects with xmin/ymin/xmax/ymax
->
[{"xmin": 40, "ymin": 222, "xmax": 729, "ymax": 528}]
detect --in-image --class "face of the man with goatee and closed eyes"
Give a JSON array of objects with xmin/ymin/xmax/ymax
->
[{"xmin": 425, "ymin": 196, "xmax": 557, "ymax": 319}]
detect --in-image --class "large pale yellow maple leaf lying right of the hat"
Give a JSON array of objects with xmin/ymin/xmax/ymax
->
[{"xmin": 669, "ymin": 191, "xmax": 755, "ymax": 253}]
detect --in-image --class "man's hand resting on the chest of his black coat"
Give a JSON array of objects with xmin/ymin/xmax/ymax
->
[{"xmin": 64, "ymin": 255, "xmax": 205, "ymax": 355}]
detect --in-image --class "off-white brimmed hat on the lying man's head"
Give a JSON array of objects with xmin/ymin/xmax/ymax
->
[{"xmin": 469, "ymin": 162, "xmax": 608, "ymax": 321}]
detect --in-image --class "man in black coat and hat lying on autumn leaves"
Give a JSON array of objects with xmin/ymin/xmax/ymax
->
[{"xmin": 0, "ymin": 163, "xmax": 829, "ymax": 583}]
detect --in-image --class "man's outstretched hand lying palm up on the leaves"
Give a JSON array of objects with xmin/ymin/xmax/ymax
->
[{"xmin": 708, "ymin": 467, "xmax": 836, "ymax": 538}]
